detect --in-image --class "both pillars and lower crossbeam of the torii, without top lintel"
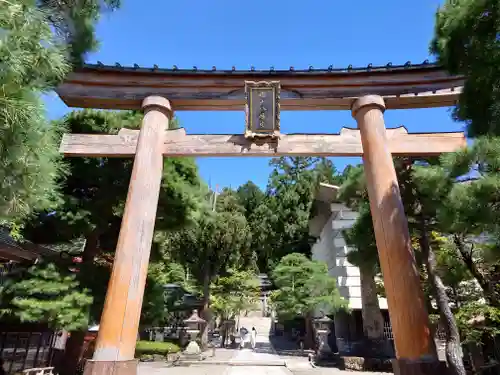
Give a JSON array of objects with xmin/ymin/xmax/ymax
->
[{"xmin": 60, "ymin": 96, "xmax": 466, "ymax": 375}]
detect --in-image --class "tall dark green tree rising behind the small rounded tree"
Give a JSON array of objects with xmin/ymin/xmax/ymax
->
[{"xmin": 249, "ymin": 157, "xmax": 342, "ymax": 271}]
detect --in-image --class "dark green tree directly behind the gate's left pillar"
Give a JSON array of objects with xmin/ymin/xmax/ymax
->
[{"xmin": 24, "ymin": 110, "xmax": 200, "ymax": 373}]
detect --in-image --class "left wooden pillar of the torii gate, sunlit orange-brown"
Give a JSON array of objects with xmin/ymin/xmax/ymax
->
[{"xmin": 85, "ymin": 96, "xmax": 172, "ymax": 375}]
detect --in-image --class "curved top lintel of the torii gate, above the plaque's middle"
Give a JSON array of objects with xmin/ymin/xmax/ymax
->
[{"xmin": 56, "ymin": 64, "xmax": 464, "ymax": 111}]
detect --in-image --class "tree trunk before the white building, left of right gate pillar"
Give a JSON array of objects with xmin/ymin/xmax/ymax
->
[{"xmin": 360, "ymin": 267, "xmax": 384, "ymax": 340}]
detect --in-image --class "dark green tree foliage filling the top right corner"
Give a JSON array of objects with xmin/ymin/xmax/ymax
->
[{"xmin": 431, "ymin": 0, "xmax": 500, "ymax": 137}]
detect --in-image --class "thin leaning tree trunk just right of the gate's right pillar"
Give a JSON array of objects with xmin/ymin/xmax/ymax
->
[{"xmin": 419, "ymin": 225, "xmax": 466, "ymax": 375}]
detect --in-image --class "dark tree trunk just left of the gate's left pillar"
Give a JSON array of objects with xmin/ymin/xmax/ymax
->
[{"xmin": 59, "ymin": 231, "xmax": 99, "ymax": 375}]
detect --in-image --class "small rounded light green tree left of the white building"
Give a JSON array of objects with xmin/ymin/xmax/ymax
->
[{"xmin": 270, "ymin": 253, "xmax": 347, "ymax": 348}]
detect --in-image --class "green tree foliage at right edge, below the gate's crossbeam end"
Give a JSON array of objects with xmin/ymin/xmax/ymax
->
[{"xmin": 418, "ymin": 138, "xmax": 500, "ymax": 307}]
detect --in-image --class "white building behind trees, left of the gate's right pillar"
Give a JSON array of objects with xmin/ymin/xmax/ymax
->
[{"xmin": 309, "ymin": 184, "xmax": 391, "ymax": 348}]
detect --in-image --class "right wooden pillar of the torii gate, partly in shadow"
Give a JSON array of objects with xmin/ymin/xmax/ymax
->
[{"xmin": 352, "ymin": 95, "xmax": 439, "ymax": 374}]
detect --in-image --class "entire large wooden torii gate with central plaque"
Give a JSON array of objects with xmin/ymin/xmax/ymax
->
[{"xmin": 57, "ymin": 63, "xmax": 466, "ymax": 375}]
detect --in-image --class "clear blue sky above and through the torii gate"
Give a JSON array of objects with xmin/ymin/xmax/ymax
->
[{"xmin": 47, "ymin": 0, "xmax": 463, "ymax": 187}]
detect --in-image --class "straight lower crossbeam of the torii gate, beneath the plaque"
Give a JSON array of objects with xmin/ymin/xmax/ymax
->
[{"xmin": 60, "ymin": 127, "xmax": 466, "ymax": 157}]
